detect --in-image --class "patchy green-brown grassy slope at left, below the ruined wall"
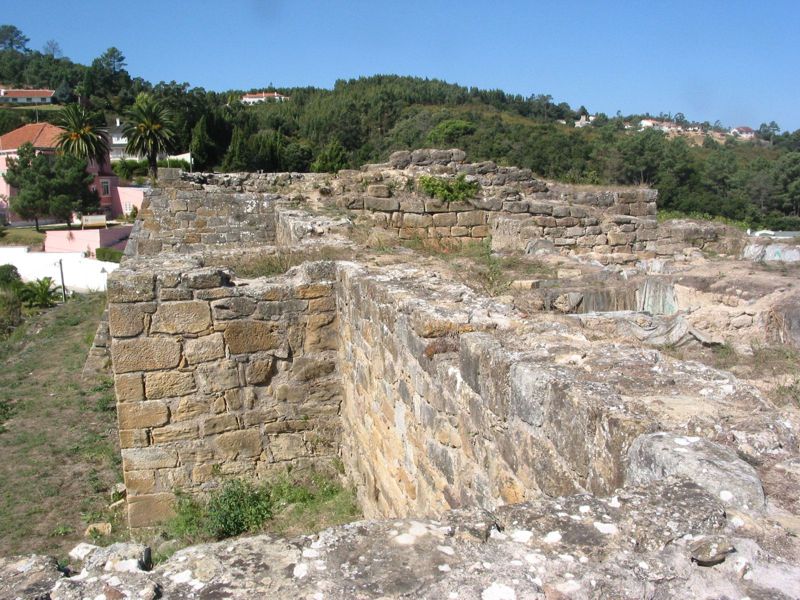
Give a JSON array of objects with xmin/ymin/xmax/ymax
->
[{"xmin": 0, "ymin": 294, "xmax": 124, "ymax": 556}]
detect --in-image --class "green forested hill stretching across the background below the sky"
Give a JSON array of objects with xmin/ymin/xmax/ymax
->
[{"xmin": 0, "ymin": 29, "xmax": 800, "ymax": 229}]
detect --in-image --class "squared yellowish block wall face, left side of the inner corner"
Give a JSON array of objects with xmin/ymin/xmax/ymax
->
[{"xmin": 108, "ymin": 255, "xmax": 342, "ymax": 528}]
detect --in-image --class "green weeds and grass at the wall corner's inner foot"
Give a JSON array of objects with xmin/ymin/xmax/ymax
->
[{"xmin": 167, "ymin": 472, "xmax": 360, "ymax": 544}]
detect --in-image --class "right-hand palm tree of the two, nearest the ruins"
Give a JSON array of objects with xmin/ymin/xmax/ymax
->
[{"xmin": 122, "ymin": 92, "xmax": 175, "ymax": 181}]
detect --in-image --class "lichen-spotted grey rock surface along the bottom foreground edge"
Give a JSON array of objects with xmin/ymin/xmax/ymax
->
[{"xmin": 6, "ymin": 478, "xmax": 800, "ymax": 600}]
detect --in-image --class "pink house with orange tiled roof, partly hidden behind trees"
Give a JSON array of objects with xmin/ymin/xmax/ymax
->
[{"xmin": 0, "ymin": 123, "xmax": 122, "ymax": 224}]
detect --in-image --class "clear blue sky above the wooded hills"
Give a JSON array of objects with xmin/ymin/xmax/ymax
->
[{"xmin": 6, "ymin": 0, "xmax": 800, "ymax": 130}]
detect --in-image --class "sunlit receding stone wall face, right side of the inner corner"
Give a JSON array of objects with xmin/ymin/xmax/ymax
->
[{"xmin": 336, "ymin": 266, "xmax": 644, "ymax": 517}]
